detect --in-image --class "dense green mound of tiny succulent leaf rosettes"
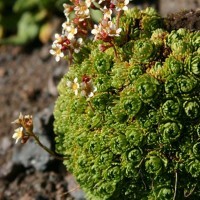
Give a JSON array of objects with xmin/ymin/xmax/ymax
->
[{"xmin": 54, "ymin": 8, "xmax": 200, "ymax": 200}]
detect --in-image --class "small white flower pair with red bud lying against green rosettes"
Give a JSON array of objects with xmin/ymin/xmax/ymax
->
[{"xmin": 66, "ymin": 75, "xmax": 97, "ymax": 98}]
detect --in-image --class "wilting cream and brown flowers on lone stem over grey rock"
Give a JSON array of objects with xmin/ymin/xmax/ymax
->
[{"xmin": 12, "ymin": 113, "xmax": 33, "ymax": 144}]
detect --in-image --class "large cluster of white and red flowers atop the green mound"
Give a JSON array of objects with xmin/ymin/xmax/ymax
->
[{"xmin": 50, "ymin": 0, "xmax": 129, "ymax": 62}]
